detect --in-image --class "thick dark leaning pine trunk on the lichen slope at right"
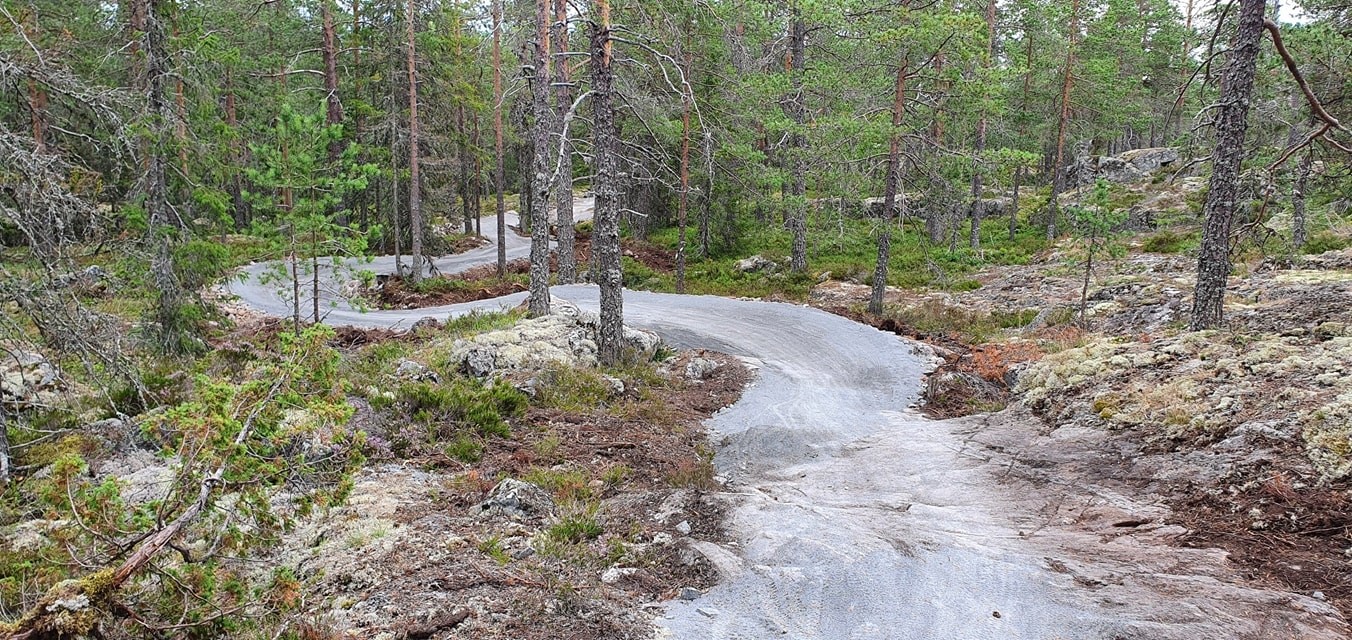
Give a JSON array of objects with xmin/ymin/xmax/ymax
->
[{"xmin": 1191, "ymin": 0, "xmax": 1267, "ymax": 332}]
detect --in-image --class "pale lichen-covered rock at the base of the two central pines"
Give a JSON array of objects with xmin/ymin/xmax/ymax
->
[{"xmin": 449, "ymin": 300, "xmax": 661, "ymax": 378}]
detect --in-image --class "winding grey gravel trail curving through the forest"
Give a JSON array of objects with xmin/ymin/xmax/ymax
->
[{"xmin": 228, "ymin": 199, "xmax": 1352, "ymax": 640}]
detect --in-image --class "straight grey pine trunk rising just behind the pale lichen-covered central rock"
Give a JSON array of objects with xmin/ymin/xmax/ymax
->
[{"xmin": 527, "ymin": 0, "xmax": 554, "ymax": 318}]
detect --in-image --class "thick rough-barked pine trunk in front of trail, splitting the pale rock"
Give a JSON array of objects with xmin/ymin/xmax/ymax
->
[{"xmin": 591, "ymin": 0, "xmax": 625, "ymax": 364}]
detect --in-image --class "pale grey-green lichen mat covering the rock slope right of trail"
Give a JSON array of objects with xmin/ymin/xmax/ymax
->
[{"xmin": 1018, "ymin": 327, "xmax": 1352, "ymax": 465}]
